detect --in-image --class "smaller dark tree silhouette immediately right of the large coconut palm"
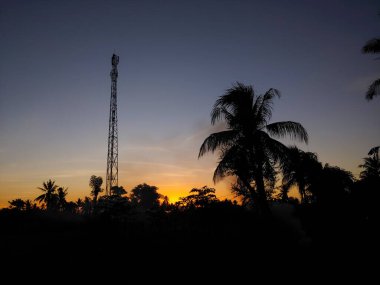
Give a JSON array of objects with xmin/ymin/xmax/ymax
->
[{"xmin": 282, "ymin": 146, "xmax": 322, "ymax": 203}]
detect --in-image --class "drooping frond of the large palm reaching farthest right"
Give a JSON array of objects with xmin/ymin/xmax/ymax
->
[{"xmin": 266, "ymin": 121, "xmax": 309, "ymax": 143}]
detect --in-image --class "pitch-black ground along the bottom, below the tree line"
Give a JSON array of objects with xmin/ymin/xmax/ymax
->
[{"xmin": 0, "ymin": 204, "xmax": 380, "ymax": 281}]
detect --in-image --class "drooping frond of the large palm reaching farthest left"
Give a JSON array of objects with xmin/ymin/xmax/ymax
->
[{"xmin": 198, "ymin": 130, "xmax": 238, "ymax": 158}]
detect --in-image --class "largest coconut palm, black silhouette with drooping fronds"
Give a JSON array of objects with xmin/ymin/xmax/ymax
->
[{"xmin": 198, "ymin": 82, "xmax": 308, "ymax": 213}]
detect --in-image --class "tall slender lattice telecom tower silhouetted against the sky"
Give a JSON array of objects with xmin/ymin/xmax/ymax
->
[{"xmin": 106, "ymin": 54, "xmax": 119, "ymax": 195}]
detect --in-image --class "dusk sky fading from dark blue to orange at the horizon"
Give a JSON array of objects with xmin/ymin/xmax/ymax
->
[{"xmin": 0, "ymin": 0, "xmax": 380, "ymax": 207}]
